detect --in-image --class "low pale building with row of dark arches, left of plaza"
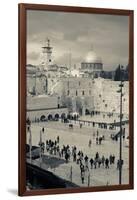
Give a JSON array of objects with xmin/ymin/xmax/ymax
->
[{"xmin": 27, "ymin": 95, "xmax": 68, "ymax": 122}]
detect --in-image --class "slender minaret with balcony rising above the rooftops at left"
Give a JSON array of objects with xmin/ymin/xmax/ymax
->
[{"xmin": 42, "ymin": 38, "xmax": 53, "ymax": 69}]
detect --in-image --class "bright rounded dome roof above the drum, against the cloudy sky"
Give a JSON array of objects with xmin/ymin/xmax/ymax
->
[{"xmin": 85, "ymin": 50, "xmax": 102, "ymax": 63}]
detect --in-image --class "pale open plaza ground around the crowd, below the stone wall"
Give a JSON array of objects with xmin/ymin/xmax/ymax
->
[{"xmin": 27, "ymin": 118, "xmax": 129, "ymax": 187}]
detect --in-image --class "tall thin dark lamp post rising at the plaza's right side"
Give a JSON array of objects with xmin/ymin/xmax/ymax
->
[{"xmin": 118, "ymin": 67, "xmax": 124, "ymax": 185}]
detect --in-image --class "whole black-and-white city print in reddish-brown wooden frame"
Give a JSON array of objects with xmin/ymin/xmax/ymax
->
[{"xmin": 19, "ymin": 4, "xmax": 134, "ymax": 196}]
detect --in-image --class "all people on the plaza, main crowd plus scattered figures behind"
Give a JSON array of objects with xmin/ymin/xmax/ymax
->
[{"xmin": 27, "ymin": 110, "xmax": 125, "ymax": 184}]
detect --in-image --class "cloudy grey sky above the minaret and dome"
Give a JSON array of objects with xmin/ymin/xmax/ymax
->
[{"xmin": 27, "ymin": 10, "xmax": 129, "ymax": 70}]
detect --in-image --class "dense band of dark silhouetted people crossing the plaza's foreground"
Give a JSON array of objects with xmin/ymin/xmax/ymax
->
[{"xmin": 39, "ymin": 133, "xmax": 120, "ymax": 184}]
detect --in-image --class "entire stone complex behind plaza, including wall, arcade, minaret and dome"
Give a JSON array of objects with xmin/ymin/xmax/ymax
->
[{"xmin": 27, "ymin": 40, "xmax": 129, "ymax": 120}]
